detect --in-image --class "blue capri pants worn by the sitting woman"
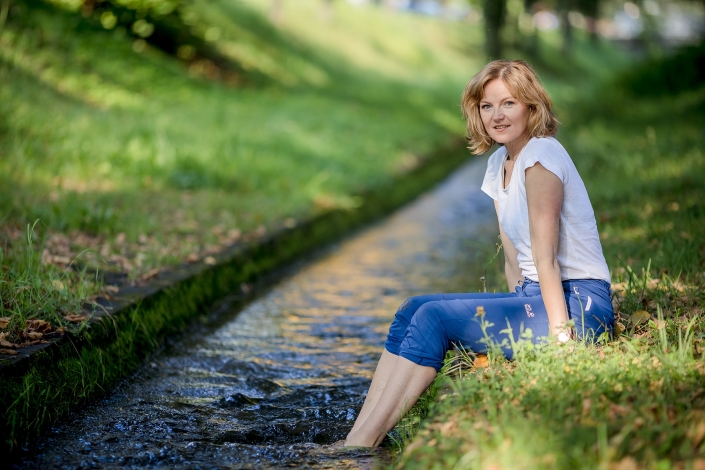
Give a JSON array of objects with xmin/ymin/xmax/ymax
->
[{"xmin": 384, "ymin": 279, "xmax": 614, "ymax": 371}]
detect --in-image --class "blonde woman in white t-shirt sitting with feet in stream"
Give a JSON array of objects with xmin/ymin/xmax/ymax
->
[{"xmin": 345, "ymin": 60, "xmax": 614, "ymax": 447}]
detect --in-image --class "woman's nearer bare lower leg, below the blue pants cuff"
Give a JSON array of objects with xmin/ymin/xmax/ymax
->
[{"xmin": 345, "ymin": 357, "xmax": 437, "ymax": 447}]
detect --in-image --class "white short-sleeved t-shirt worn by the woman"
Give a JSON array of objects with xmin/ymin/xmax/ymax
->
[{"xmin": 482, "ymin": 137, "xmax": 610, "ymax": 282}]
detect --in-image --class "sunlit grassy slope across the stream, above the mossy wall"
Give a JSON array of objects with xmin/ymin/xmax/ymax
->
[{"xmin": 0, "ymin": 0, "xmax": 480, "ymax": 338}]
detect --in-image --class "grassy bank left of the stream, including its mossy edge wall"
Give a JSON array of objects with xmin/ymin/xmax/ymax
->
[{"xmin": 0, "ymin": 0, "xmax": 490, "ymax": 449}]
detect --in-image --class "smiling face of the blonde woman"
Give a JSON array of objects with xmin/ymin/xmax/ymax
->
[{"xmin": 480, "ymin": 78, "xmax": 529, "ymax": 145}]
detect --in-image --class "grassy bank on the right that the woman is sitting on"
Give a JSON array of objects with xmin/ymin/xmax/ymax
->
[{"xmin": 400, "ymin": 37, "xmax": 705, "ymax": 469}]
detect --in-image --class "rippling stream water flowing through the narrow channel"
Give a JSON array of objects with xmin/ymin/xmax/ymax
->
[{"xmin": 11, "ymin": 160, "xmax": 497, "ymax": 469}]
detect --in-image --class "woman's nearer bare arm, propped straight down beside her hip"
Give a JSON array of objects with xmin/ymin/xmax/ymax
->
[{"xmin": 526, "ymin": 163, "xmax": 568, "ymax": 335}]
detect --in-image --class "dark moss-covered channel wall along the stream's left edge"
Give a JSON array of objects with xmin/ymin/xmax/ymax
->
[{"xmin": 0, "ymin": 141, "xmax": 469, "ymax": 452}]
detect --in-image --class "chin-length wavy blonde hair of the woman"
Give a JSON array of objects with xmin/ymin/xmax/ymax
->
[{"xmin": 460, "ymin": 60, "xmax": 558, "ymax": 155}]
